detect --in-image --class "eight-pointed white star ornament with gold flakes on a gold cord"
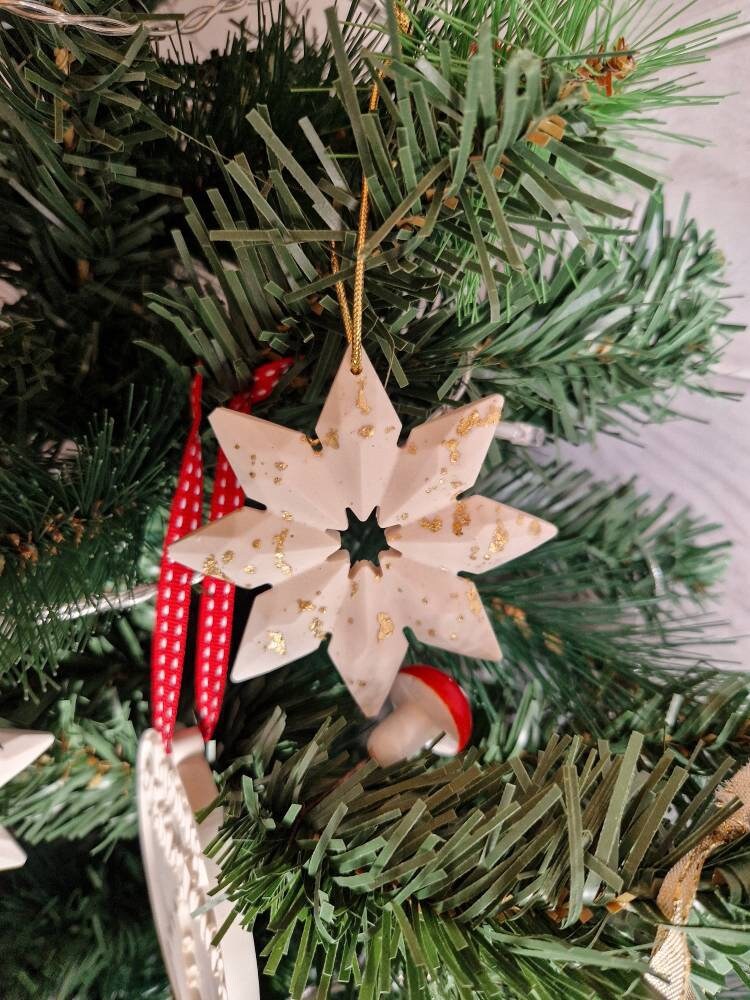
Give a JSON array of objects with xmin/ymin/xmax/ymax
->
[{"xmin": 169, "ymin": 350, "xmax": 556, "ymax": 716}]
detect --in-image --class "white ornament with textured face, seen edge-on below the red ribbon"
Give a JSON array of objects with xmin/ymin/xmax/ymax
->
[{"xmin": 136, "ymin": 728, "xmax": 260, "ymax": 1000}]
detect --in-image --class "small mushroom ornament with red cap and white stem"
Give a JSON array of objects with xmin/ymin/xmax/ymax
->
[{"xmin": 367, "ymin": 664, "xmax": 472, "ymax": 767}]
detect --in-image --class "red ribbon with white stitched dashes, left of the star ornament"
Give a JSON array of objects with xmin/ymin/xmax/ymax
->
[{"xmin": 151, "ymin": 358, "xmax": 292, "ymax": 751}]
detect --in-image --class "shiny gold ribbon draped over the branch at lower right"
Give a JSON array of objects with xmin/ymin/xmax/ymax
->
[{"xmin": 646, "ymin": 764, "xmax": 750, "ymax": 1000}]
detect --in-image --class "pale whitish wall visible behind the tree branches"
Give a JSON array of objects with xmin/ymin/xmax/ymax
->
[{"xmin": 165, "ymin": 0, "xmax": 750, "ymax": 668}]
